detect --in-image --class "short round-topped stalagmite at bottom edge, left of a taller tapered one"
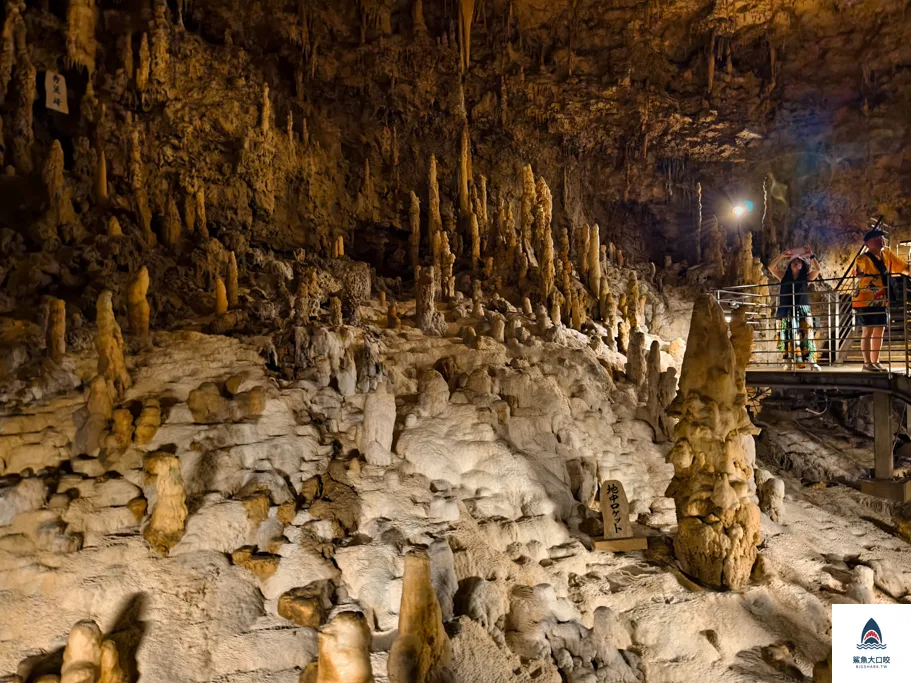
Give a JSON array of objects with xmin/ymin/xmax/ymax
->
[{"xmin": 301, "ymin": 612, "xmax": 374, "ymax": 683}]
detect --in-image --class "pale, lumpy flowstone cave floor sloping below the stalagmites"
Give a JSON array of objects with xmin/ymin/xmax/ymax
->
[{"xmin": 0, "ymin": 274, "xmax": 911, "ymax": 683}]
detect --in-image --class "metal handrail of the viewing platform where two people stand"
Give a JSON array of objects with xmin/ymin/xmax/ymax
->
[{"xmin": 715, "ymin": 272, "xmax": 911, "ymax": 374}]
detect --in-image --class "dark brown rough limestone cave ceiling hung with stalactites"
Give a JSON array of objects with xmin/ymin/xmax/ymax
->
[{"xmin": 0, "ymin": 0, "xmax": 911, "ymax": 272}]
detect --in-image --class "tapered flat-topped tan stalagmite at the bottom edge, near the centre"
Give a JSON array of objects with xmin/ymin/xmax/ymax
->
[{"xmin": 387, "ymin": 550, "xmax": 451, "ymax": 683}]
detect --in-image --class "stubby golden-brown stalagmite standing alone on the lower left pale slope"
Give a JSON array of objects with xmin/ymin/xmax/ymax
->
[{"xmin": 142, "ymin": 451, "xmax": 187, "ymax": 555}]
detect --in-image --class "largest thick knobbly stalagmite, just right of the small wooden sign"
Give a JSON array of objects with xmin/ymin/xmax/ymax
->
[{"xmin": 666, "ymin": 294, "xmax": 761, "ymax": 589}]
